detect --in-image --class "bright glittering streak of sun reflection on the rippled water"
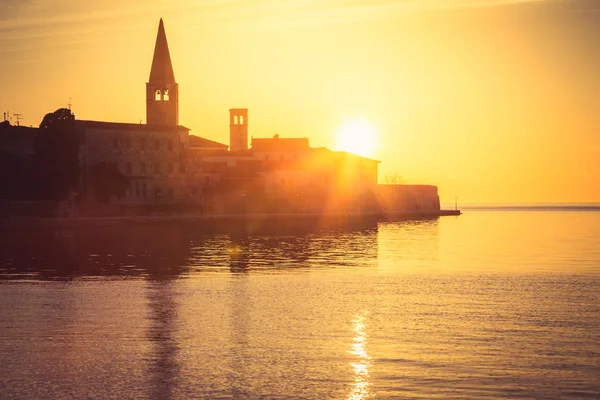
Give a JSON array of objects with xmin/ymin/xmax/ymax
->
[{"xmin": 348, "ymin": 314, "xmax": 371, "ymax": 400}]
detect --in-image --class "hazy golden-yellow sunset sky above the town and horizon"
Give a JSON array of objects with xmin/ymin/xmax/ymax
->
[{"xmin": 0, "ymin": 0, "xmax": 600, "ymax": 203}]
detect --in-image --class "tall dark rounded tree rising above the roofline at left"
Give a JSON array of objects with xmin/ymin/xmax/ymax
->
[{"xmin": 33, "ymin": 108, "xmax": 79, "ymax": 200}]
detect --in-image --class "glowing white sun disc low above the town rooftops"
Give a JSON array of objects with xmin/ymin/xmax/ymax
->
[{"xmin": 336, "ymin": 118, "xmax": 378, "ymax": 157}]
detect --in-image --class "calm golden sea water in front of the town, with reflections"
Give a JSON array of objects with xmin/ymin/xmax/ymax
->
[{"xmin": 0, "ymin": 209, "xmax": 600, "ymax": 399}]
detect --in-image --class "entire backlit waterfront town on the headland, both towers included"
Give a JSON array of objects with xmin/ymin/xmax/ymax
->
[{"xmin": 0, "ymin": 19, "xmax": 458, "ymax": 225}]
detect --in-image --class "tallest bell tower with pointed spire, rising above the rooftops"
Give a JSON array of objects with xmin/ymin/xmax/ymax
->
[{"xmin": 146, "ymin": 18, "xmax": 179, "ymax": 125}]
